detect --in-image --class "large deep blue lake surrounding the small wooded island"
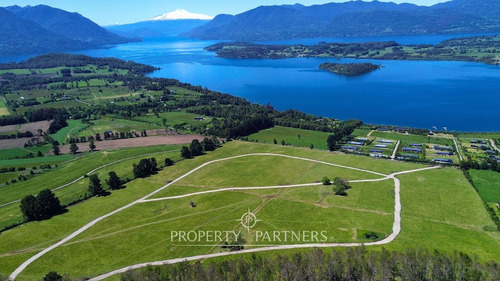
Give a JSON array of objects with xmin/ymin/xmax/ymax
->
[{"xmin": 3, "ymin": 35, "xmax": 500, "ymax": 131}]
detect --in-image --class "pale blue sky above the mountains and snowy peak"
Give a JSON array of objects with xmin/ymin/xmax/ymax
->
[{"xmin": 0, "ymin": 0, "xmax": 452, "ymax": 25}]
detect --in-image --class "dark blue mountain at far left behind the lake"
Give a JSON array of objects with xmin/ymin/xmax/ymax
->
[{"xmin": 0, "ymin": 5, "xmax": 132, "ymax": 56}]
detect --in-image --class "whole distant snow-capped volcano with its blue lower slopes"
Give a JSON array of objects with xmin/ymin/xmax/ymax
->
[{"xmin": 106, "ymin": 9, "xmax": 213, "ymax": 38}]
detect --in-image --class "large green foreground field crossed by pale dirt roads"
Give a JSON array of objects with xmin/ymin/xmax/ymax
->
[{"xmin": 0, "ymin": 142, "xmax": 500, "ymax": 280}]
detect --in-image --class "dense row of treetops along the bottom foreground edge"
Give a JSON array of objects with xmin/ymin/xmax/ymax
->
[{"xmin": 120, "ymin": 247, "xmax": 500, "ymax": 281}]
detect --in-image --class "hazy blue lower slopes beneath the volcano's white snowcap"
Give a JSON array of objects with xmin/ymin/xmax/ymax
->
[{"xmin": 106, "ymin": 20, "xmax": 209, "ymax": 38}]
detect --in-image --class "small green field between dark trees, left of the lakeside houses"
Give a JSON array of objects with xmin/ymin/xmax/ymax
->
[{"xmin": 248, "ymin": 126, "xmax": 328, "ymax": 150}]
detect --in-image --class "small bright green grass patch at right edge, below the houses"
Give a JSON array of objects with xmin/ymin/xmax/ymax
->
[{"xmin": 469, "ymin": 170, "xmax": 500, "ymax": 203}]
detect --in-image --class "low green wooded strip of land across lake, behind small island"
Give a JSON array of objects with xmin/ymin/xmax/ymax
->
[{"xmin": 205, "ymin": 35, "xmax": 500, "ymax": 65}]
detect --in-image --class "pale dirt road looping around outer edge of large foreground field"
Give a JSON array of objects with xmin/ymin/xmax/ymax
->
[{"xmin": 9, "ymin": 153, "xmax": 439, "ymax": 280}]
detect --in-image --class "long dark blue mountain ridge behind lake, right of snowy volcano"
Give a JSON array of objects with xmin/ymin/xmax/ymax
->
[{"xmin": 183, "ymin": 0, "xmax": 500, "ymax": 40}]
